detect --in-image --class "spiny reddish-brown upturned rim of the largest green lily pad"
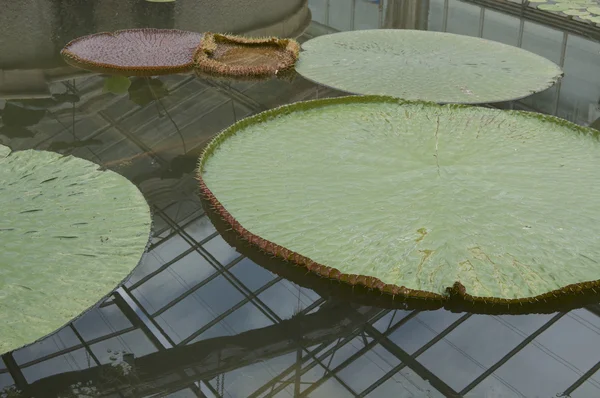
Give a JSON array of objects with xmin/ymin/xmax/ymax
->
[{"xmin": 196, "ymin": 95, "xmax": 600, "ymax": 312}]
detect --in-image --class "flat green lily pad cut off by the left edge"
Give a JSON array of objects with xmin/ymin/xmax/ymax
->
[{"xmin": 0, "ymin": 146, "xmax": 151, "ymax": 353}]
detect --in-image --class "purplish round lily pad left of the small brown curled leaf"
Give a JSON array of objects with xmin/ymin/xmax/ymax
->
[{"xmin": 61, "ymin": 28, "xmax": 203, "ymax": 76}]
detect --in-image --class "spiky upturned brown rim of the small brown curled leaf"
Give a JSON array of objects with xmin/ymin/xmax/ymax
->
[{"xmin": 194, "ymin": 32, "xmax": 300, "ymax": 78}]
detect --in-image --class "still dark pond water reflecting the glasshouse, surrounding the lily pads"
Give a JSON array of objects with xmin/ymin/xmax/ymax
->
[{"xmin": 0, "ymin": 0, "xmax": 600, "ymax": 398}]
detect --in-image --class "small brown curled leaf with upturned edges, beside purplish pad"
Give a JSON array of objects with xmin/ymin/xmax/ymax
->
[{"xmin": 194, "ymin": 33, "xmax": 300, "ymax": 79}]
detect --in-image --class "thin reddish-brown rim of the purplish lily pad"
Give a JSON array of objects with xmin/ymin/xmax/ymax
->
[{"xmin": 60, "ymin": 28, "xmax": 202, "ymax": 77}]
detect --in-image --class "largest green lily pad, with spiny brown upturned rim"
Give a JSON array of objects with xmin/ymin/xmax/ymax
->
[{"xmin": 198, "ymin": 96, "xmax": 600, "ymax": 307}]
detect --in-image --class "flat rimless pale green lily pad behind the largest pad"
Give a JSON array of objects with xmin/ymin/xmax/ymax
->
[{"xmin": 296, "ymin": 29, "xmax": 562, "ymax": 104}]
